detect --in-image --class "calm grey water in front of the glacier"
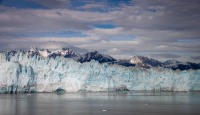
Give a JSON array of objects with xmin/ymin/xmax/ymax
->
[{"xmin": 0, "ymin": 92, "xmax": 200, "ymax": 115}]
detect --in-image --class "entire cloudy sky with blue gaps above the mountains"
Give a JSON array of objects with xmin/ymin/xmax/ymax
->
[{"xmin": 0, "ymin": 0, "xmax": 200, "ymax": 62}]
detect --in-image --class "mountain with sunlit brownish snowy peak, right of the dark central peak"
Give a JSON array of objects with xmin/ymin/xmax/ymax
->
[{"xmin": 130, "ymin": 56, "xmax": 163, "ymax": 68}]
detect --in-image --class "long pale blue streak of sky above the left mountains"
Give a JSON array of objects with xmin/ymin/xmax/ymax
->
[{"xmin": 16, "ymin": 31, "xmax": 88, "ymax": 38}]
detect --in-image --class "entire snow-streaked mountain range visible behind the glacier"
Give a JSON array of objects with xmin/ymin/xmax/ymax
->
[{"xmin": 3, "ymin": 47, "xmax": 200, "ymax": 70}]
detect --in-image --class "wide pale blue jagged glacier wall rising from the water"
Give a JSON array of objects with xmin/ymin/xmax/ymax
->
[{"xmin": 0, "ymin": 52, "xmax": 200, "ymax": 93}]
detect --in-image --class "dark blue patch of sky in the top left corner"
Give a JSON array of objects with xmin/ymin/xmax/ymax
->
[{"xmin": 0, "ymin": 0, "xmax": 45, "ymax": 9}]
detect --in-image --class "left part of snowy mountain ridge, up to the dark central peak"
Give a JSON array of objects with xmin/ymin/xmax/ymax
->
[{"xmin": 8, "ymin": 47, "xmax": 116, "ymax": 63}]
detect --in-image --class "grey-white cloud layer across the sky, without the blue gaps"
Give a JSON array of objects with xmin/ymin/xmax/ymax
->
[{"xmin": 0, "ymin": 0, "xmax": 200, "ymax": 62}]
